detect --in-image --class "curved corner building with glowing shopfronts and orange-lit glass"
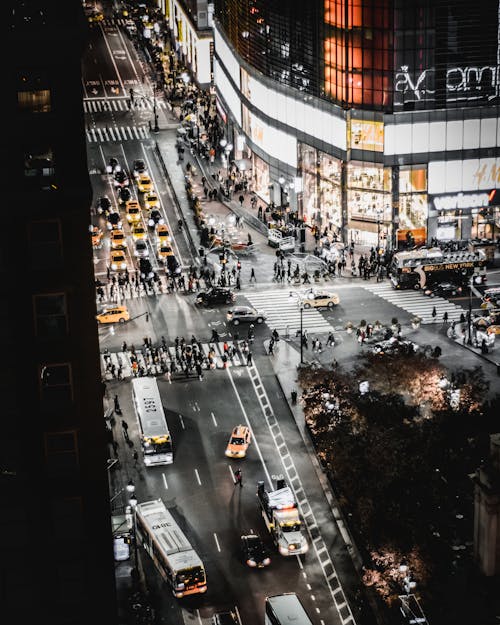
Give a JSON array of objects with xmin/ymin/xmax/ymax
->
[{"xmin": 214, "ymin": 0, "xmax": 500, "ymax": 248}]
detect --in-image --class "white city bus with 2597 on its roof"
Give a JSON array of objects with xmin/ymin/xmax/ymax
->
[{"xmin": 132, "ymin": 377, "xmax": 174, "ymax": 467}]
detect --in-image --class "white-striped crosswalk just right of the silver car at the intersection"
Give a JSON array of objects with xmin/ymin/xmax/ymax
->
[{"xmin": 245, "ymin": 289, "xmax": 333, "ymax": 334}]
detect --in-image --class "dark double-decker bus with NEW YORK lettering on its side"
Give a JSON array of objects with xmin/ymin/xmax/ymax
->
[{"xmin": 389, "ymin": 247, "xmax": 487, "ymax": 289}]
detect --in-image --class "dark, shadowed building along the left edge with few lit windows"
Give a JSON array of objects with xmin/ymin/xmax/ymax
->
[{"xmin": 0, "ymin": 0, "xmax": 117, "ymax": 625}]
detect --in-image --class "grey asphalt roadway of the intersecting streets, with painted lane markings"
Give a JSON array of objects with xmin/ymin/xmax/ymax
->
[{"xmin": 84, "ymin": 11, "xmax": 496, "ymax": 625}]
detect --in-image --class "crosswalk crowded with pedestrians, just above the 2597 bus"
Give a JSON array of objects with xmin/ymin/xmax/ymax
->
[{"xmin": 101, "ymin": 342, "xmax": 247, "ymax": 380}]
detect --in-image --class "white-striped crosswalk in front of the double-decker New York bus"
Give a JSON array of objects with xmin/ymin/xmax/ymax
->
[{"xmin": 361, "ymin": 282, "xmax": 465, "ymax": 323}]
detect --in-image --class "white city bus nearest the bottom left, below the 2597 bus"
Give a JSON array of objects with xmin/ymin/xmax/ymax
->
[{"xmin": 135, "ymin": 499, "xmax": 207, "ymax": 599}]
